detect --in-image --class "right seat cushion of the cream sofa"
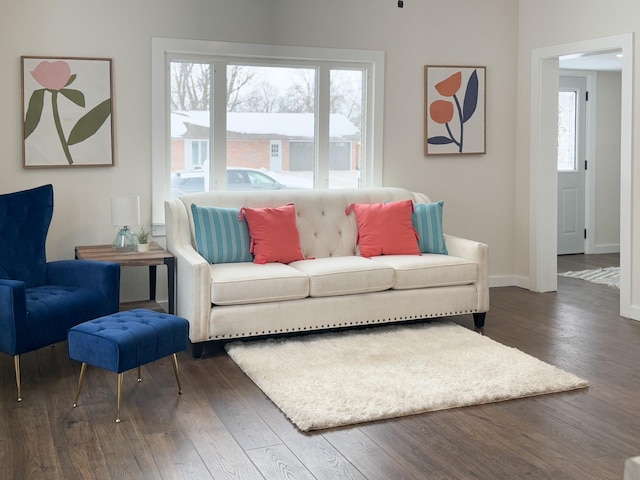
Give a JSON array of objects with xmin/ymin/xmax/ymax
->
[{"xmin": 372, "ymin": 253, "xmax": 478, "ymax": 290}]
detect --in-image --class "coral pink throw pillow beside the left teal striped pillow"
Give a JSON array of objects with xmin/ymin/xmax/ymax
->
[{"xmin": 240, "ymin": 203, "xmax": 304, "ymax": 263}]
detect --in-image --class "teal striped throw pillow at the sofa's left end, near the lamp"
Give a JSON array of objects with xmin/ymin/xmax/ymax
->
[{"xmin": 191, "ymin": 204, "xmax": 253, "ymax": 263}]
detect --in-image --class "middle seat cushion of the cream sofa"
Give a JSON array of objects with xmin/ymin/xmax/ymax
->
[{"xmin": 289, "ymin": 256, "xmax": 394, "ymax": 297}]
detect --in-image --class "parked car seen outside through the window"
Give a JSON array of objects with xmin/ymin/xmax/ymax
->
[{"xmin": 171, "ymin": 167, "xmax": 287, "ymax": 194}]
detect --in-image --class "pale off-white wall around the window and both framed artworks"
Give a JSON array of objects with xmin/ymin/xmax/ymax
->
[{"xmin": 0, "ymin": 0, "xmax": 518, "ymax": 300}]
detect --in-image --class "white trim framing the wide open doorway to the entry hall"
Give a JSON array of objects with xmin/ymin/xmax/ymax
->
[{"xmin": 529, "ymin": 33, "xmax": 640, "ymax": 320}]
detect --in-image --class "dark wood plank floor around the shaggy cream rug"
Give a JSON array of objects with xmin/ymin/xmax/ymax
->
[{"xmin": 0, "ymin": 253, "xmax": 640, "ymax": 480}]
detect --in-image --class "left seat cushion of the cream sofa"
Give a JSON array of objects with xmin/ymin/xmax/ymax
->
[{"xmin": 210, "ymin": 262, "xmax": 309, "ymax": 305}]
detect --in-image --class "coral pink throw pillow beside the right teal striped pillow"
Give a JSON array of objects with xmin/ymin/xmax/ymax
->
[{"xmin": 347, "ymin": 200, "xmax": 421, "ymax": 257}]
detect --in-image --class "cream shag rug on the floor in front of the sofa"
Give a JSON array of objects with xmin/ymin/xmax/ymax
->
[{"xmin": 226, "ymin": 321, "xmax": 587, "ymax": 431}]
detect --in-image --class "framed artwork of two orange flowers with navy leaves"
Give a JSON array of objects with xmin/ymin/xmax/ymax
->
[{"xmin": 424, "ymin": 65, "xmax": 486, "ymax": 155}]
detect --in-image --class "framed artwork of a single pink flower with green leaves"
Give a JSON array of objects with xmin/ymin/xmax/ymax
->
[{"xmin": 21, "ymin": 56, "xmax": 114, "ymax": 168}]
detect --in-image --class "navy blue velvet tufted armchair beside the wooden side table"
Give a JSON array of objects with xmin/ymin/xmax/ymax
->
[{"xmin": 0, "ymin": 185, "xmax": 120, "ymax": 401}]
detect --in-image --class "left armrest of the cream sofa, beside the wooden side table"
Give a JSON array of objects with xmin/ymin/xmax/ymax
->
[{"xmin": 165, "ymin": 199, "xmax": 211, "ymax": 342}]
